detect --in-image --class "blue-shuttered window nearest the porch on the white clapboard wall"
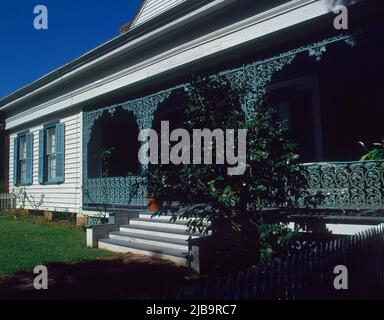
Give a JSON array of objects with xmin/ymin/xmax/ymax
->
[{"xmin": 39, "ymin": 123, "xmax": 65, "ymax": 184}]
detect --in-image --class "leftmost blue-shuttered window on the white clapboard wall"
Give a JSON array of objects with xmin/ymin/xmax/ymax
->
[{"xmin": 13, "ymin": 132, "xmax": 33, "ymax": 185}]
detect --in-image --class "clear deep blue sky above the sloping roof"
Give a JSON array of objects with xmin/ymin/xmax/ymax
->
[{"xmin": 0, "ymin": 0, "xmax": 141, "ymax": 98}]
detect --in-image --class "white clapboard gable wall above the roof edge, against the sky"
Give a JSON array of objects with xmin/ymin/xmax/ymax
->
[{"xmin": 133, "ymin": 0, "xmax": 186, "ymax": 27}]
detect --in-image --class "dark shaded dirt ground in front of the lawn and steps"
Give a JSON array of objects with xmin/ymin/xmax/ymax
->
[{"xmin": 0, "ymin": 254, "xmax": 194, "ymax": 300}]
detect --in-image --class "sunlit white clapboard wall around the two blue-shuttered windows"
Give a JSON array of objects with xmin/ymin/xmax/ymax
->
[{"xmin": 9, "ymin": 113, "xmax": 82, "ymax": 213}]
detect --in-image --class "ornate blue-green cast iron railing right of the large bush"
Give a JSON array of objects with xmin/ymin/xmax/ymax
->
[{"xmin": 298, "ymin": 161, "xmax": 384, "ymax": 209}]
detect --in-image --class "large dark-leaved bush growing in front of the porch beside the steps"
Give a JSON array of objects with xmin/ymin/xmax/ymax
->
[{"xmin": 148, "ymin": 78, "xmax": 303, "ymax": 261}]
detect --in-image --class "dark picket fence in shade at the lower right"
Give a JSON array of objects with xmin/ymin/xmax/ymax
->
[{"xmin": 163, "ymin": 225, "xmax": 384, "ymax": 300}]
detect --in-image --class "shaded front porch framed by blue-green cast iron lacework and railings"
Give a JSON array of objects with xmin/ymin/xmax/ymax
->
[{"xmin": 83, "ymin": 34, "xmax": 384, "ymax": 214}]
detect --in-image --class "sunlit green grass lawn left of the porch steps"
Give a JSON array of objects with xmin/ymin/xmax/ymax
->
[{"xmin": 0, "ymin": 215, "xmax": 113, "ymax": 276}]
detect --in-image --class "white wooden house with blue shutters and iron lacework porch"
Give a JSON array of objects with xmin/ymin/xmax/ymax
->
[{"xmin": 0, "ymin": 0, "xmax": 384, "ymax": 266}]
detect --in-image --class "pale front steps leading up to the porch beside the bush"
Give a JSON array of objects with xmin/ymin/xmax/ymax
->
[{"xmin": 98, "ymin": 212, "xmax": 210, "ymax": 266}]
